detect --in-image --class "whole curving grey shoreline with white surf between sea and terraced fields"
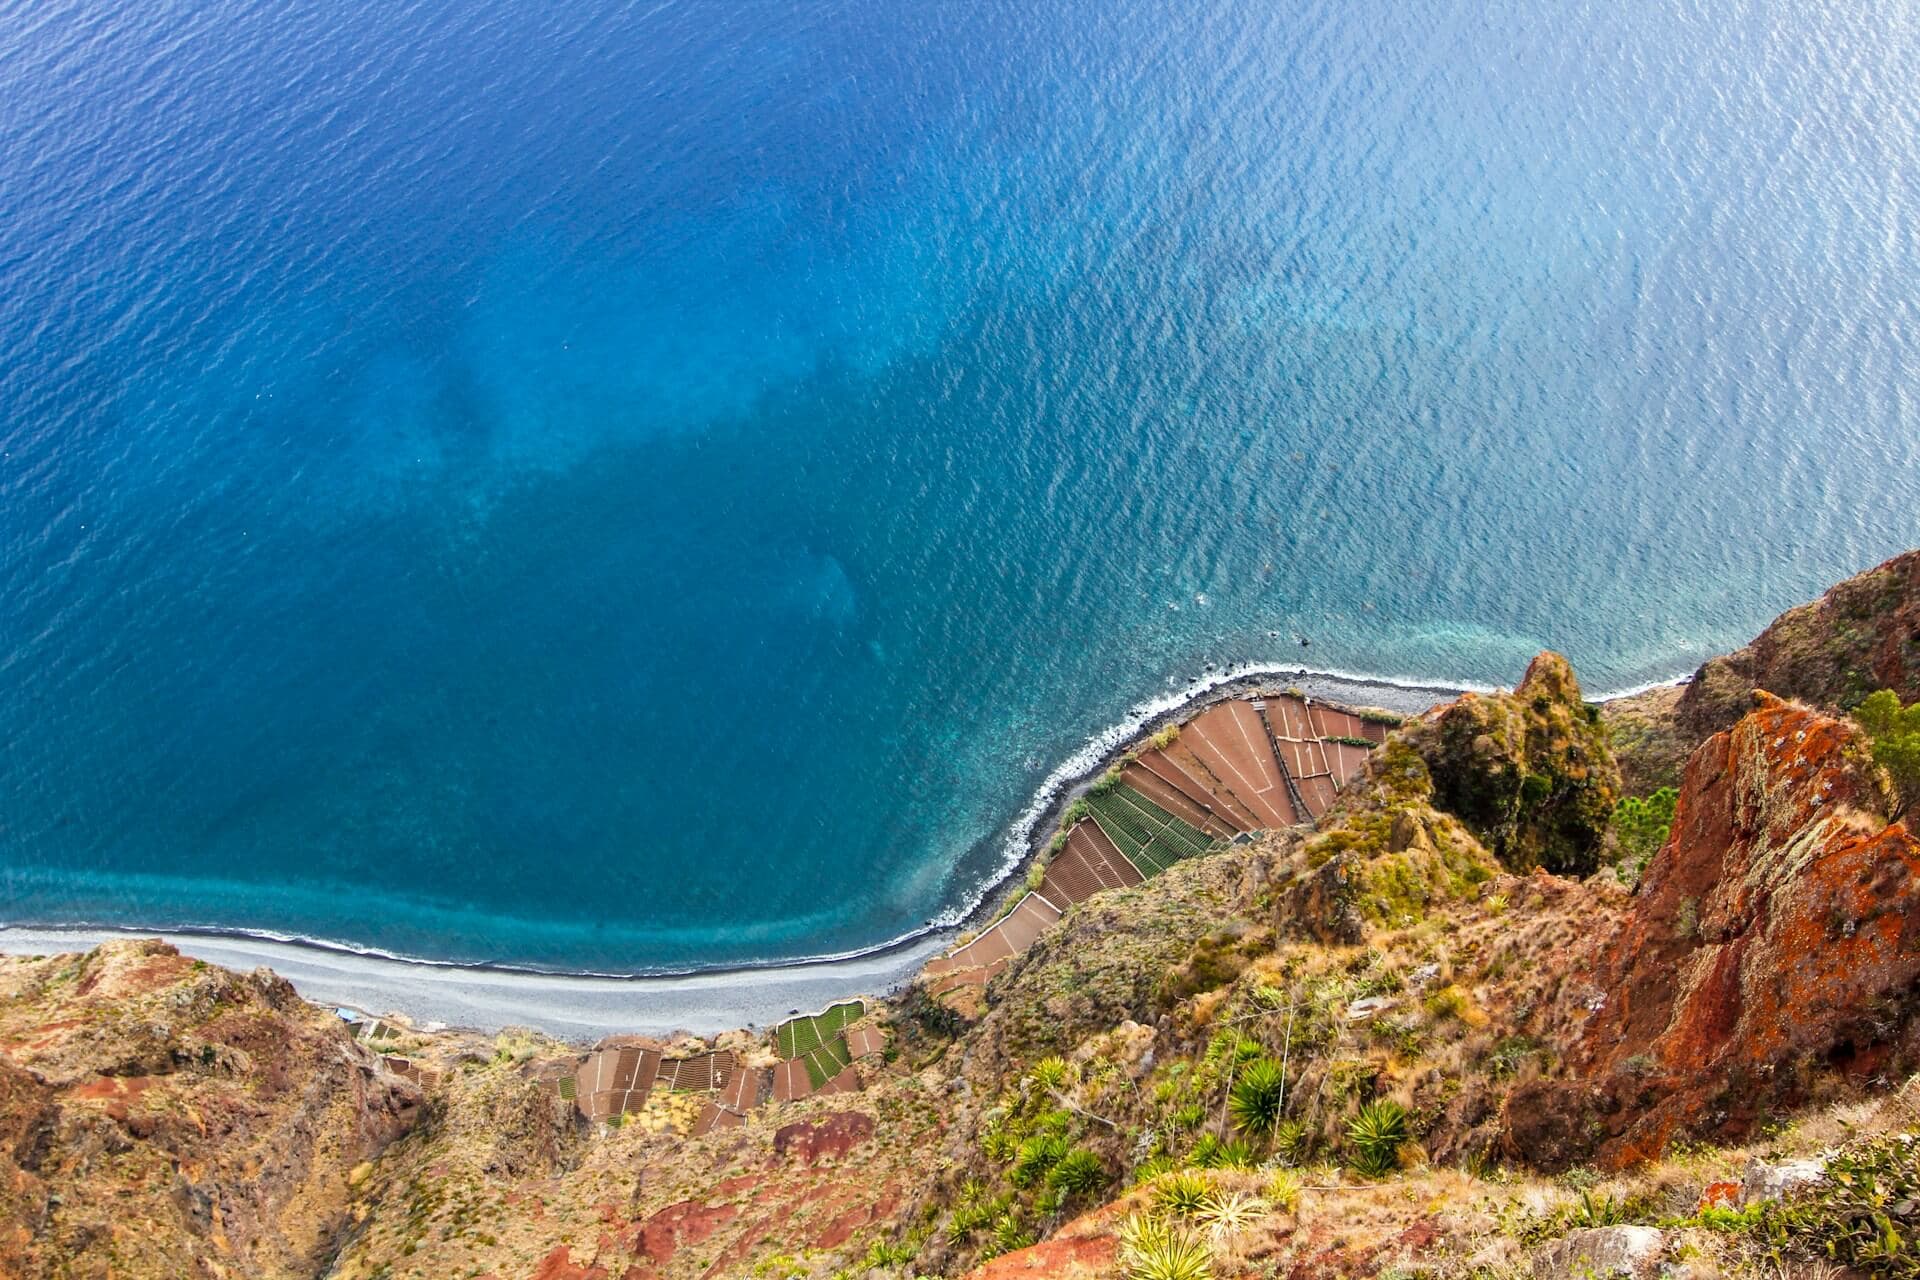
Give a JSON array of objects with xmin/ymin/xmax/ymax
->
[{"xmin": 0, "ymin": 662, "xmax": 1684, "ymax": 1040}]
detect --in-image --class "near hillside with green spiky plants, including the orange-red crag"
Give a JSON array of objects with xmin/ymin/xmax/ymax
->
[{"xmin": 948, "ymin": 695, "xmax": 1920, "ymax": 1278}]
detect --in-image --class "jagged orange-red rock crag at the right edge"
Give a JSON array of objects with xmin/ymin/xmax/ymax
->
[{"xmin": 1507, "ymin": 693, "xmax": 1920, "ymax": 1167}]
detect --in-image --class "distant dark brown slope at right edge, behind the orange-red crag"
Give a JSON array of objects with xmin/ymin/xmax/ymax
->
[{"xmin": 1676, "ymin": 551, "xmax": 1920, "ymax": 743}]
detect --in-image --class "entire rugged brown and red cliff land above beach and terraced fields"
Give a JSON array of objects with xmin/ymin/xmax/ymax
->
[{"xmin": 0, "ymin": 557, "xmax": 1920, "ymax": 1280}]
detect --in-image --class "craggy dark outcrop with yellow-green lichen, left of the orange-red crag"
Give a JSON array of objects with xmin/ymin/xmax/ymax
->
[{"xmin": 1407, "ymin": 652, "xmax": 1620, "ymax": 875}]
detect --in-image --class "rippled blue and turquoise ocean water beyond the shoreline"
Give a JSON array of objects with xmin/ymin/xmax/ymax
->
[{"xmin": 0, "ymin": 0, "xmax": 1920, "ymax": 969}]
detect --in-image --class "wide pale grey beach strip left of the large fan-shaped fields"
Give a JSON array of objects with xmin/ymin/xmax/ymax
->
[{"xmin": 0, "ymin": 929, "xmax": 952, "ymax": 1040}]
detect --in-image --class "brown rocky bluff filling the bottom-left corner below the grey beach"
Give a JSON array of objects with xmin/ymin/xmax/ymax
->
[{"xmin": 0, "ymin": 942, "xmax": 420, "ymax": 1280}]
